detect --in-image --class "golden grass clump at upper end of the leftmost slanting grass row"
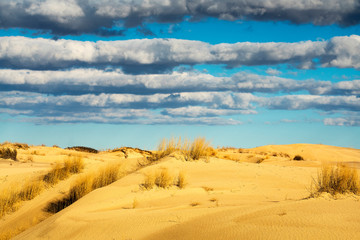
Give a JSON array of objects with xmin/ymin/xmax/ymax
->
[{"xmin": 43, "ymin": 156, "xmax": 84, "ymax": 185}]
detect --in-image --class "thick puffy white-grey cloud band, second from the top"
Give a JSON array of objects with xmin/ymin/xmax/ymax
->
[{"xmin": 0, "ymin": 35, "xmax": 360, "ymax": 74}]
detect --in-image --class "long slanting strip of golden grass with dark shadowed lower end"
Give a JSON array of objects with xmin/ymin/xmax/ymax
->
[{"xmin": 47, "ymin": 163, "xmax": 121, "ymax": 213}]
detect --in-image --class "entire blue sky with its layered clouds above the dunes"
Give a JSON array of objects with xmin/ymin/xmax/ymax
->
[{"xmin": 0, "ymin": 0, "xmax": 360, "ymax": 149}]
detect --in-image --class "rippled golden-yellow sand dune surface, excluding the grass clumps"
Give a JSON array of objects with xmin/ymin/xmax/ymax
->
[{"xmin": 0, "ymin": 144, "xmax": 360, "ymax": 239}]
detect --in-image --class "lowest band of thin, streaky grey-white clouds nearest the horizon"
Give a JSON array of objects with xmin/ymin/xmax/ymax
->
[{"xmin": 0, "ymin": 91, "xmax": 360, "ymax": 126}]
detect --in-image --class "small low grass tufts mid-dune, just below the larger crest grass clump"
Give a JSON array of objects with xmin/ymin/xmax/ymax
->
[{"xmin": 141, "ymin": 168, "xmax": 186, "ymax": 190}]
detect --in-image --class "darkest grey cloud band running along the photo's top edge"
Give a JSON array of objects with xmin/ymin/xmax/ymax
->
[{"xmin": 0, "ymin": 0, "xmax": 360, "ymax": 35}]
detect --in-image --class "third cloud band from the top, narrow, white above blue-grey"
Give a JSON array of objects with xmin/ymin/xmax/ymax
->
[{"xmin": 0, "ymin": 68, "xmax": 360, "ymax": 96}]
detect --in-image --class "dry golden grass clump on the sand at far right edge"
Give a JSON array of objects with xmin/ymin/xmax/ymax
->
[{"xmin": 311, "ymin": 164, "xmax": 360, "ymax": 197}]
